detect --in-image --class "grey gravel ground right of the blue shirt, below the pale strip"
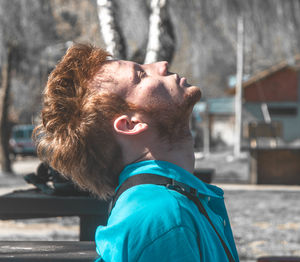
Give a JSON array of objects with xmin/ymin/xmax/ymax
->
[{"xmin": 225, "ymin": 190, "xmax": 300, "ymax": 261}]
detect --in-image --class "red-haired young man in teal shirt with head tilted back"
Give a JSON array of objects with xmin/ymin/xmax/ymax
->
[{"xmin": 35, "ymin": 44, "xmax": 238, "ymax": 262}]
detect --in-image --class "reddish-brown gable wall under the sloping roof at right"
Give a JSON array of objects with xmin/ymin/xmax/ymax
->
[{"xmin": 243, "ymin": 68, "xmax": 298, "ymax": 102}]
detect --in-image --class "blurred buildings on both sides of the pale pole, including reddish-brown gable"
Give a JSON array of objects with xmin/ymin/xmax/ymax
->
[{"xmin": 193, "ymin": 55, "xmax": 300, "ymax": 150}]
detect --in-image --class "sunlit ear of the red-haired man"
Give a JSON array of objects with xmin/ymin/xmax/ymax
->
[{"xmin": 114, "ymin": 115, "xmax": 148, "ymax": 135}]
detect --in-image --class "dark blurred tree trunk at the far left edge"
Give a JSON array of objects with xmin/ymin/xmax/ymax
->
[{"xmin": 0, "ymin": 47, "xmax": 13, "ymax": 173}]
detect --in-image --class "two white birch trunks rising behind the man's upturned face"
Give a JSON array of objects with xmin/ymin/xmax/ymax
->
[{"xmin": 97, "ymin": 0, "xmax": 175, "ymax": 63}]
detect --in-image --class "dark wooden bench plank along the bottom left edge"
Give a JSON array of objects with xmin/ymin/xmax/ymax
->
[{"xmin": 0, "ymin": 241, "xmax": 98, "ymax": 262}]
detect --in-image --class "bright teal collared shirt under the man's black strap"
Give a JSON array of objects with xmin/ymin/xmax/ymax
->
[{"xmin": 95, "ymin": 160, "xmax": 239, "ymax": 262}]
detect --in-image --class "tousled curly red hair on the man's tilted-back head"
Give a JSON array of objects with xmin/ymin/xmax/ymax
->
[{"xmin": 33, "ymin": 44, "xmax": 130, "ymax": 198}]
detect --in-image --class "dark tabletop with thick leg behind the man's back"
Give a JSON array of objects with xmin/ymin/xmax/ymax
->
[{"xmin": 0, "ymin": 189, "xmax": 108, "ymax": 241}]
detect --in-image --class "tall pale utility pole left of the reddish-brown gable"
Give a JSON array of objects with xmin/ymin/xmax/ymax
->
[{"xmin": 234, "ymin": 16, "xmax": 244, "ymax": 157}]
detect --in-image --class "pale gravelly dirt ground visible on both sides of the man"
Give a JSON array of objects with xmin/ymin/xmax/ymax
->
[{"xmin": 0, "ymin": 153, "xmax": 300, "ymax": 262}]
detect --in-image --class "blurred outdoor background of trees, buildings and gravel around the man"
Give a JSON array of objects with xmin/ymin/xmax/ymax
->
[{"xmin": 0, "ymin": 0, "xmax": 300, "ymax": 261}]
